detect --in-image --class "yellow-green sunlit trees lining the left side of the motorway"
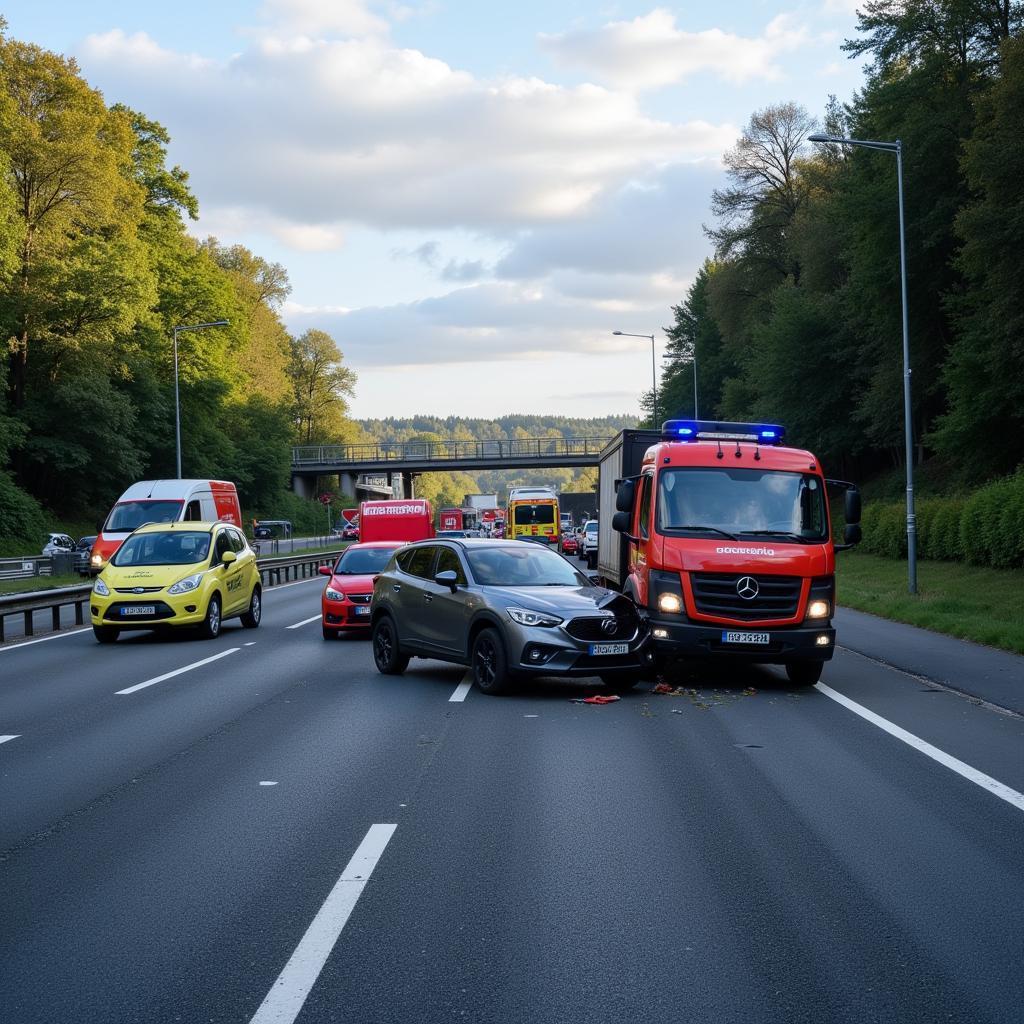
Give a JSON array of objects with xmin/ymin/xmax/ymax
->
[{"xmin": 0, "ymin": 19, "xmax": 354, "ymax": 546}]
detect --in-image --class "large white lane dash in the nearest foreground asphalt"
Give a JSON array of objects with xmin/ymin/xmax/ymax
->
[{"xmin": 250, "ymin": 824, "xmax": 398, "ymax": 1024}]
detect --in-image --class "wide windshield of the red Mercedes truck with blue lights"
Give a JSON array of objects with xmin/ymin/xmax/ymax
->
[{"xmin": 657, "ymin": 468, "xmax": 828, "ymax": 544}]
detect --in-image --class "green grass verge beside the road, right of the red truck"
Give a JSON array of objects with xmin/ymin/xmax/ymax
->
[{"xmin": 836, "ymin": 551, "xmax": 1024, "ymax": 654}]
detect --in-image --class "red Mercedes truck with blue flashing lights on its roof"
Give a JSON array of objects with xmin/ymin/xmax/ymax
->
[{"xmin": 597, "ymin": 420, "xmax": 860, "ymax": 686}]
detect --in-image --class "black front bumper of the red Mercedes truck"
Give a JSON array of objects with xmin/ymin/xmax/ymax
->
[{"xmin": 648, "ymin": 617, "xmax": 836, "ymax": 665}]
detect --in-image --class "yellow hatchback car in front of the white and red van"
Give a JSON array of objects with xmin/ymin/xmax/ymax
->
[{"xmin": 89, "ymin": 522, "xmax": 262, "ymax": 643}]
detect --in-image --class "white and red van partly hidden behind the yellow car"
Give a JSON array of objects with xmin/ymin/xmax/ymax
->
[{"xmin": 89, "ymin": 480, "xmax": 242, "ymax": 575}]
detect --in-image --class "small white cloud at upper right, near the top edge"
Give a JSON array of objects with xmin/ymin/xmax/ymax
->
[{"xmin": 540, "ymin": 7, "xmax": 810, "ymax": 91}]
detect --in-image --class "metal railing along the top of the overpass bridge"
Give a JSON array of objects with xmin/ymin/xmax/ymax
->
[{"xmin": 292, "ymin": 437, "xmax": 610, "ymax": 466}]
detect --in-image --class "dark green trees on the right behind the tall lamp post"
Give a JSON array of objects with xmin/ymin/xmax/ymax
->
[{"xmin": 645, "ymin": 0, "xmax": 1024, "ymax": 492}]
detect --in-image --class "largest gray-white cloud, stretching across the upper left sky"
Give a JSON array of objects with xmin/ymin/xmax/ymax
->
[{"xmin": 81, "ymin": 32, "xmax": 735, "ymax": 248}]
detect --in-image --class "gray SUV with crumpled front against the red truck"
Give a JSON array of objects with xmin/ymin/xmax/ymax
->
[{"xmin": 372, "ymin": 538, "xmax": 653, "ymax": 693}]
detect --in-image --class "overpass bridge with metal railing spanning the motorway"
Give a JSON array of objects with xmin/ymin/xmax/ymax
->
[{"xmin": 292, "ymin": 437, "xmax": 611, "ymax": 498}]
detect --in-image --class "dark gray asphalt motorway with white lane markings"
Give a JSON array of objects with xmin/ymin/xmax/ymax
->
[{"xmin": 0, "ymin": 580, "xmax": 1024, "ymax": 1024}]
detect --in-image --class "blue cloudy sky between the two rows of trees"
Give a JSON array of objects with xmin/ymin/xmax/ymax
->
[{"xmin": 3, "ymin": 0, "xmax": 862, "ymax": 418}]
